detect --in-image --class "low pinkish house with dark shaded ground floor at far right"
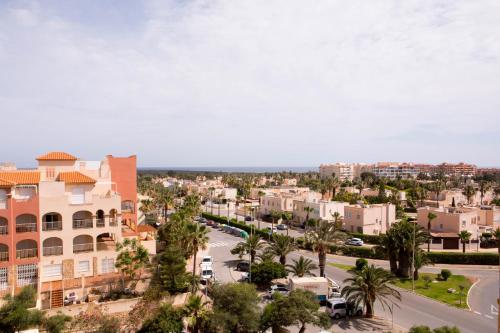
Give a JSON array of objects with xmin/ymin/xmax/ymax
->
[{"xmin": 417, "ymin": 207, "xmax": 491, "ymax": 249}]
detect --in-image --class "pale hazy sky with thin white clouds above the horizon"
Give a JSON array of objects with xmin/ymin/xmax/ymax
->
[{"xmin": 0, "ymin": 0, "xmax": 500, "ymax": 167}]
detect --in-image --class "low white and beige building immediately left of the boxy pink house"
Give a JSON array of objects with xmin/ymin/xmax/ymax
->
[{"xmin": 293, "ymin": 200, "xmax": 349, "ymax": 223}]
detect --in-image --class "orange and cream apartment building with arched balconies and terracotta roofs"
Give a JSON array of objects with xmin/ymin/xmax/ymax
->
[{"xmin": 0, "ymin": 152, "xmax": 143, "ymax": 308}]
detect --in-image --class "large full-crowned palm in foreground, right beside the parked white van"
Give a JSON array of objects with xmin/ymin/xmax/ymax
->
[{"xmin": 342, "ymin": 265, "xmax": 401, "ymax": 318}]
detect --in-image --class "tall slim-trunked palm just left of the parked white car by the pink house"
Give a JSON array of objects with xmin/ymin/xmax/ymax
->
[{"xmin": 306, "ymin": 220, "xmax": 346, "ymax": 276}]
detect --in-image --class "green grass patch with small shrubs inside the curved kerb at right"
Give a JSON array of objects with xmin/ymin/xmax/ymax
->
[{"xmin": 394, "ymin": 273, "xmax": 472, "ymax": 308}]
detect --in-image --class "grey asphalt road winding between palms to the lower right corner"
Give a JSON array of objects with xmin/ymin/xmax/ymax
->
[{"xmin": 208, "ymin": 229, "xmax": 498, "ymax": 333}]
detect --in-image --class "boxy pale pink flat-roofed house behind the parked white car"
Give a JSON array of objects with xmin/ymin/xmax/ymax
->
[{"xmin": 343, "ymin": 204, "xmax": 396, "ymax": 235}]
